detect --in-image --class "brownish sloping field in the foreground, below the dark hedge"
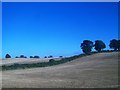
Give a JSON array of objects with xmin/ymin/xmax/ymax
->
[{"xmin": 2, "ymin": 52, "xmax": 119, "ymax": 88}]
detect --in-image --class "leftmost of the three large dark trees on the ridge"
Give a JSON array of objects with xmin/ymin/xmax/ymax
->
[{"xmin": 80, "ymin": 40, "xmax": 94, "ymax": 54}]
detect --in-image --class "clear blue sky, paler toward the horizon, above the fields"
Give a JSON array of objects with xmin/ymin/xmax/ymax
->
[{"xmin": 2, "ymin": 2, "xmax": 118, "ymax": 57}]
